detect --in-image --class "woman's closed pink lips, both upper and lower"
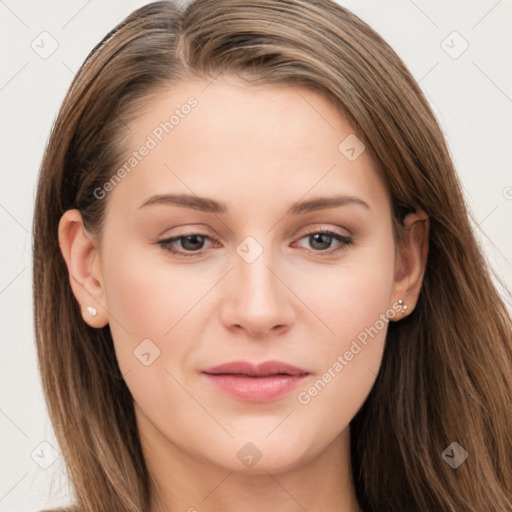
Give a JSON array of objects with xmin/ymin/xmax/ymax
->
[{"xmin": 202, "ymin": 361, "xmax": 309, "ymax": 402}]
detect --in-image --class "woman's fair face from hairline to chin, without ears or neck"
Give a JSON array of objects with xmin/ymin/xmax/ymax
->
[{"xmin": 91, "ymin": 79, "xmax": 400, "ymax": 472}]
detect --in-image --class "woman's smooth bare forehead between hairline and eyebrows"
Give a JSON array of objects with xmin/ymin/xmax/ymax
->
[{"xmin": 105, "ymin": 78, "xmax": 386, "ymax": 216}]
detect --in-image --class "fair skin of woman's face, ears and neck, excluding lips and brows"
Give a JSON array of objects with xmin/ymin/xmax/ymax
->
[{"xmin": 59, "ymin": 77, "xmax": 428, "ymax": 512}]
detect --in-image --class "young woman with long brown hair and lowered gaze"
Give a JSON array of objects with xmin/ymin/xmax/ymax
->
[{"xmin": 34, "ymin": 0, "xmax": 512, "ymax": 512}]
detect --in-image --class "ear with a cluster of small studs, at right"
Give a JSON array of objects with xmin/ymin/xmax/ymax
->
[{"xmin": 393, "ymin": 210, "xmax": 430, "ymax": 320}]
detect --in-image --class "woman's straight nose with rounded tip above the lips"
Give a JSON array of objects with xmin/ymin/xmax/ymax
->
[{"xmin": 221, "ymin": 246, "xmax": 294, "ymax": 338}]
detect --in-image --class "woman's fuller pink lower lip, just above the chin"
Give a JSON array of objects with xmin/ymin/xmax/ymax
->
[{"xmin": 204, "ymin": 373, "xmax": 307, "ymax": 402}]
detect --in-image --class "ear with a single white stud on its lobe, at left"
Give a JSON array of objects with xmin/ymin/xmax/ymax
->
[{"xmin": 59, "ymin": 210, "xmax": 108, "ymax": 328}]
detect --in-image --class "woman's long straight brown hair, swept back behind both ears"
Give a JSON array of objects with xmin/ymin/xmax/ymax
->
[{"xmin": 33, "ymin": 0, "xmax": 512, "ymax": 512}]
